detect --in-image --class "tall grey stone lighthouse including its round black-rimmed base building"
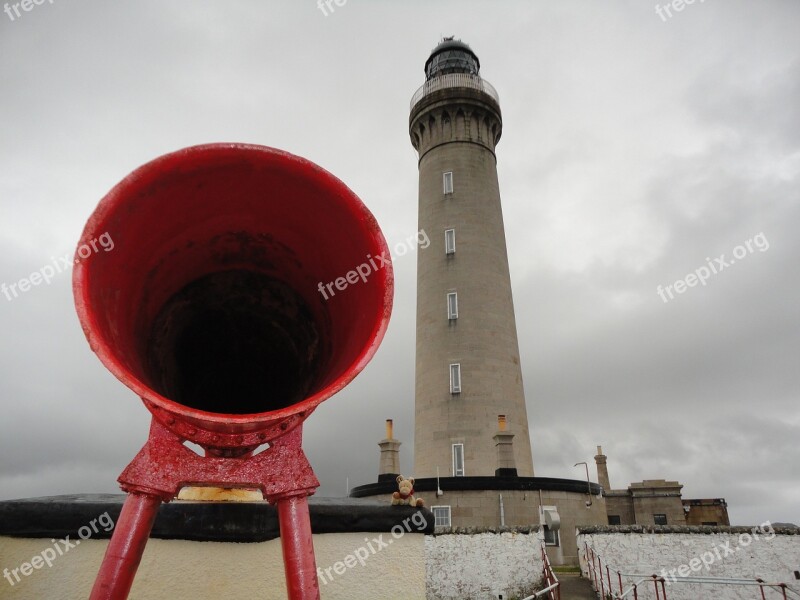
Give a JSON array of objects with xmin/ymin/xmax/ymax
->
[{"xmin": 350, "ymin": 38, "xmax": 608, "ymax": 564}]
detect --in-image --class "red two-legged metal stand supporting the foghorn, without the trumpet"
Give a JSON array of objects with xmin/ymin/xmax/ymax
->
[{"xmin": 89, "ymin": 419, "xmax": 319, "ymax": 600}]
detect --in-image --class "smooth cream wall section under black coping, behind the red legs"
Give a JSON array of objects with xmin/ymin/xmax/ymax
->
[{"xmin": 0, "ymin": 533, "xmax": 425, "ymax": 600}]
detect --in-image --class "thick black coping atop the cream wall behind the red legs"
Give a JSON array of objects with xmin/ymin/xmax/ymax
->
[{"xmin": 0, "ymin": 494, "xmax": 434, "ymax": 542}]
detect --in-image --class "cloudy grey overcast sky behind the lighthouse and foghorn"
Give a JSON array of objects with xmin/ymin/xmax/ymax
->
[{"xmin": 0, "ymin": 0, "xmax": 800, "ymax": 524}]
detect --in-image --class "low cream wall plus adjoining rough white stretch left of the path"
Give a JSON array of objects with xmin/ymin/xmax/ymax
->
[{"xmin": 0, "ymin": 531, "xmax": 542, "ymax": 600}]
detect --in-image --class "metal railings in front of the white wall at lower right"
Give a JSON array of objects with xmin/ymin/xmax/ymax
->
[{"xmin": 584, "ymin": 542, "xmax": 800, "ymax": 600}]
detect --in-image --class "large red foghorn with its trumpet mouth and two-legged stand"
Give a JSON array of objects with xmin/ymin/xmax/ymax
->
[{"xmin": 73, "ymin": 143, "xmax": 394, "ymax": 600}]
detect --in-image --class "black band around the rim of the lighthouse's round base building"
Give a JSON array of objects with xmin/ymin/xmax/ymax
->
[{"xmin": 350, "ymin": 477, "xmax": 602, "ymax": 498}]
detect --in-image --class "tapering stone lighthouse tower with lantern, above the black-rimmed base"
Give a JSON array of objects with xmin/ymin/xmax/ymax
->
[{"xmin": 409, "ymin": 38, "xmax": 533, "ymax": 477}]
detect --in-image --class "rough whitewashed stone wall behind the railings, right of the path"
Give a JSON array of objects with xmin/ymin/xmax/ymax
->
[{"xmin": 577, "ymin": 523, "xmax": 800, "ymax": 600}]
